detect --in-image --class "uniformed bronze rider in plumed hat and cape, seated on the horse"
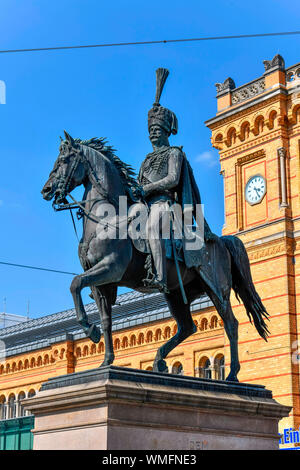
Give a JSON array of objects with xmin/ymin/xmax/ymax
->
[{"xmin": 138, "ymin": 69, "xmax": 214, "ymax": 292}]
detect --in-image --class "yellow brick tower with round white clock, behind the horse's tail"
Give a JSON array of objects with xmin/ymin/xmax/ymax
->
[{"xmin": 206, "ymin": 55, "xmax": 300, "ymax": 440}]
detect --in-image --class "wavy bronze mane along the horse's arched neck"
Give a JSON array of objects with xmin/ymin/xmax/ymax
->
[{"xmin": 74, "ymin": 137, "xmax": 141, "ymax": 202}]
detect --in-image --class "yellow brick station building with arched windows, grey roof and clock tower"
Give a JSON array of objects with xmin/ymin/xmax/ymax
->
[{"xmin": 0, "ymin": 55, "xmax": 300, "ymax": 448}]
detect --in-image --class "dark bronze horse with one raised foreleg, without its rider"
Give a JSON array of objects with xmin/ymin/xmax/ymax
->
[{"xmin": 42, "ymin": 132, "xmax": 269, "ymax": 381}]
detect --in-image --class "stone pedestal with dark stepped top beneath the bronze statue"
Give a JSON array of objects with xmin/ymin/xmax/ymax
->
[{"xmin": 23, "ymin": 366, "xmax": 290, "ymax": 450}]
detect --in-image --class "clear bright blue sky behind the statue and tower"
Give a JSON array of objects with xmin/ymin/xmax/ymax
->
[{"xmin": 0, "ymin": 0, "xmax": 300, "ymax": 317}]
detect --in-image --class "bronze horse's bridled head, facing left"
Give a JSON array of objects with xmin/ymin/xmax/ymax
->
[{"xmin": 41, "ymin": 131, "xmax": 85, "ymax": 204}]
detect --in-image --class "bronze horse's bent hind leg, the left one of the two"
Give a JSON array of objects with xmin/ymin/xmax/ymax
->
[{"xmin": 153, "ymin": 289, "xmax": 197, "ymax": 372}]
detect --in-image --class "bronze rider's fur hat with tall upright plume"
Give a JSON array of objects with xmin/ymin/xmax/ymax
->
[{"xmin": 148, "ymin": 68, "xmax": 178, "ymax": 135}]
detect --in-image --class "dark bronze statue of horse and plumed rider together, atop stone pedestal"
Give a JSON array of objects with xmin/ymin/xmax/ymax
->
[{"xmin": 42, "ymin": 69, "xmax": 269, "ymax": 381}]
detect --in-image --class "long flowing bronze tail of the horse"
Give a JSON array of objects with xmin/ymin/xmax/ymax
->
[{"xmin": 221, "ymin": 235, "xmax": 270, "ymax": 341}]
